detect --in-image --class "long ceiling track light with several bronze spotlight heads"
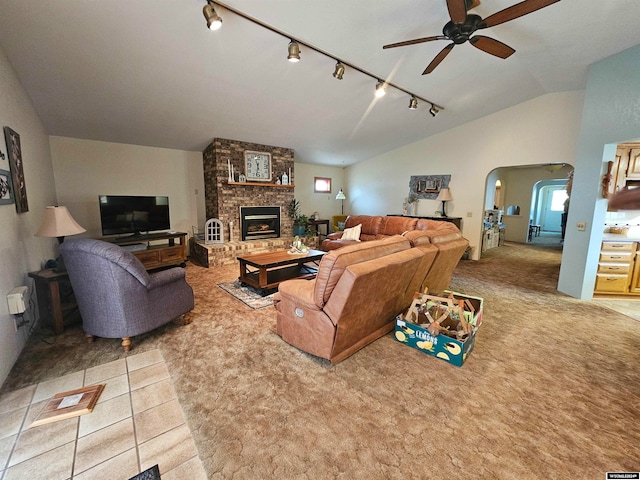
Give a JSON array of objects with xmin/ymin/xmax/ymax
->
[{"xmin": 202, "ymin": 0, "xmax": 442, "ymax": 116}]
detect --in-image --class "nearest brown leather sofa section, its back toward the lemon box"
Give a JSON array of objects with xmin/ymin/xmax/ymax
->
[{"xmin": 274, "ymin": 235, "xmax": 438, "ymax": 364}]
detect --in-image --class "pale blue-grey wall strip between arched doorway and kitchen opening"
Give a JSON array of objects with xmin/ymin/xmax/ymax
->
[{"xmin": 558, "ymin": 45, "xmax": 640, "ymax": 299}]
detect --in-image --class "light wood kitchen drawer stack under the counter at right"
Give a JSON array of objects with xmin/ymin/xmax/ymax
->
[{"xmin": 594, "ymin": 241, "xmax": 640, "ymax": 295}]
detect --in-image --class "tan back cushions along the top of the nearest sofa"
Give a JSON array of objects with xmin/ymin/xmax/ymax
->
[{"xmin": 313, "ymin": 235, "xmax": 411, "ymax": 308}]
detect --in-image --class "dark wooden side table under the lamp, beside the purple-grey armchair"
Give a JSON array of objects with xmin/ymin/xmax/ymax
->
[{"xmin": 29, "ymin": 268, "xmax": 78, "ymax": 335}]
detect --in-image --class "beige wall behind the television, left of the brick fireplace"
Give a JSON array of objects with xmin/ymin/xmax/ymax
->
[{"xmin": 51, "ymin": 137, "xmax": 205, "ymax": 238}]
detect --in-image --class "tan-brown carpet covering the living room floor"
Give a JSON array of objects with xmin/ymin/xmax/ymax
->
[{"xmin": 3, "ymin": 244, "xmax": 640, "ymax": 480}]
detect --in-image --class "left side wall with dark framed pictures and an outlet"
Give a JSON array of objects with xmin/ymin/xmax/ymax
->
[{"xmin": 0, "ymin": 49, "xmax": 57, "ymax": 383}]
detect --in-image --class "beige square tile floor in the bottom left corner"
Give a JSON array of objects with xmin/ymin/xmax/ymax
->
[{"xmin": 0, "ymin": 350, "xmax": 207, "ymax": 480}]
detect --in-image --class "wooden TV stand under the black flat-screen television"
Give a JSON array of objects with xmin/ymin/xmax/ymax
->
[{"xmin": 102, "ymin": 232, "xmax": 187, "ymax": 270}]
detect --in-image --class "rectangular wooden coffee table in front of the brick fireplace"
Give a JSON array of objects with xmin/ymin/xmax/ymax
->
[{"xmin": 238, "ymin": 250, "xmax": 326, "ymax": 295}]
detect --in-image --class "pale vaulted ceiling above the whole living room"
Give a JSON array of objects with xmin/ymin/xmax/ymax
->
[{"xmin": 0, "ymin": 0, "xmax": 640, "ymax": 166}]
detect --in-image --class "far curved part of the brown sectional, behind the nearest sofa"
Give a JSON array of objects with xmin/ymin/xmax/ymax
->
[{"xmin": 320, "ymin": 215, "xmax": 469, "ymax": 293}]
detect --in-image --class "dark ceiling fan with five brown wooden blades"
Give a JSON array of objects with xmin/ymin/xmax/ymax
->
[{"xmin": 382, "ymin": 0, "xmax": 560, "ymax": 75}]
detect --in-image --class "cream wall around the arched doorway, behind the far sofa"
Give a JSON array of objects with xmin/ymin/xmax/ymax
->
[{"xmin": 346, "ymin": 92, "xmax": 583, "ymax": 259}]
